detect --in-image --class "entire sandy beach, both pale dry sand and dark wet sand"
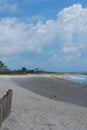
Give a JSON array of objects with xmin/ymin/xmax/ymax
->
[{"xmin": 0, "ymin": 75, "xmax": 87, "ymax": 130}]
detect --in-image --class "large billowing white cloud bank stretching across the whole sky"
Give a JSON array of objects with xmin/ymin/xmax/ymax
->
[{"xmin": 0, "ymin": 4, "xmax": 87, "ymax": 63}]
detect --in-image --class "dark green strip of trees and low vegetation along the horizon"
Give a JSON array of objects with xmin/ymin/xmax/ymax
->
[{"xmin": 0, "ymin": 61, "xmax": 87, "ymax": 75}]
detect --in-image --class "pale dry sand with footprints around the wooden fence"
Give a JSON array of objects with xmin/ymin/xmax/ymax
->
[{"xmin": 0, "ymin": 75, "xmax": 87, "ymax": 130}]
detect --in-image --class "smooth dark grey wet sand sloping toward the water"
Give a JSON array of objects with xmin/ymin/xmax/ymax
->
[{"xmin": 12, "ymin": 76, "xmax": 87, "ymax": 107}]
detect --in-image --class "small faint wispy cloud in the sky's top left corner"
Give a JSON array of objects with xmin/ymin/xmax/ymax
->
[{"xmin": 0, "ymin": 0, "xmax": 18, "ymax": 12}]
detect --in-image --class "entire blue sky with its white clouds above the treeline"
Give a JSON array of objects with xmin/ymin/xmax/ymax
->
[{"xmin": 0, "ymin": 0, "xmax": 87, "ymax": 72}]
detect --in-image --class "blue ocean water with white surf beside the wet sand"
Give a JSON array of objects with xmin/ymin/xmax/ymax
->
[{"xmin": 66, "ymin": 75, "xmax": 87, "ymax": 84}]
